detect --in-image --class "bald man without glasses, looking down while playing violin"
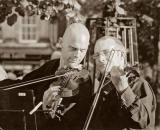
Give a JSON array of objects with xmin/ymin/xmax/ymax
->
[{"xmin": 0, "ymin": 23, "xmax": 91, "ymax": 130}]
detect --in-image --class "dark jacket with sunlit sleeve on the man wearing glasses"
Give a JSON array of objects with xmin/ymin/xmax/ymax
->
[{"xmin": 90, "ymin": 74, "xmax": 156, "ymax": 130}]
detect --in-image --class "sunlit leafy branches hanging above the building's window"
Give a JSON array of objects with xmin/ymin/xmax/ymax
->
[{"xmin": 0, "ymin": 0, "xmax": 80, "ymax": 26}]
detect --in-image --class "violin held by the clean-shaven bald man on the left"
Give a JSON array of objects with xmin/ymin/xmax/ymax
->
[{"xmin": 43, "ymin": 69, "xmax": 89, "ymax": 120}]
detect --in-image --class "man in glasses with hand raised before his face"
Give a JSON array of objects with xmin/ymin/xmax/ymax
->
[{"xmin": 91, "ymin": 36, "xmax": 156, "ymax": 130}]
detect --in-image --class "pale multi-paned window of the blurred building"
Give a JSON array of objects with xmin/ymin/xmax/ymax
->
[{"xmin": 20, "ymin": 16, "xmax": 37, "ymax": 43}]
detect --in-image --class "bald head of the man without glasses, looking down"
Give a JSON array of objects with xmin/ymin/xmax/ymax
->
[{"xmin": 61, "ymin": 23, "xmax": 90, "ymax": 68}]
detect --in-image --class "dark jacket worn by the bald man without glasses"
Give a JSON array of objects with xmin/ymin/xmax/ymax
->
[{"xmin": 0, "ymin": 60, "xmax": 92, "ymax": 130}]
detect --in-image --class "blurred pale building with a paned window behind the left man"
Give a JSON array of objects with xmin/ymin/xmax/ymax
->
[{"xmin": 0, "ymin": 16, "xmax": 66, "ymax": 78}]
